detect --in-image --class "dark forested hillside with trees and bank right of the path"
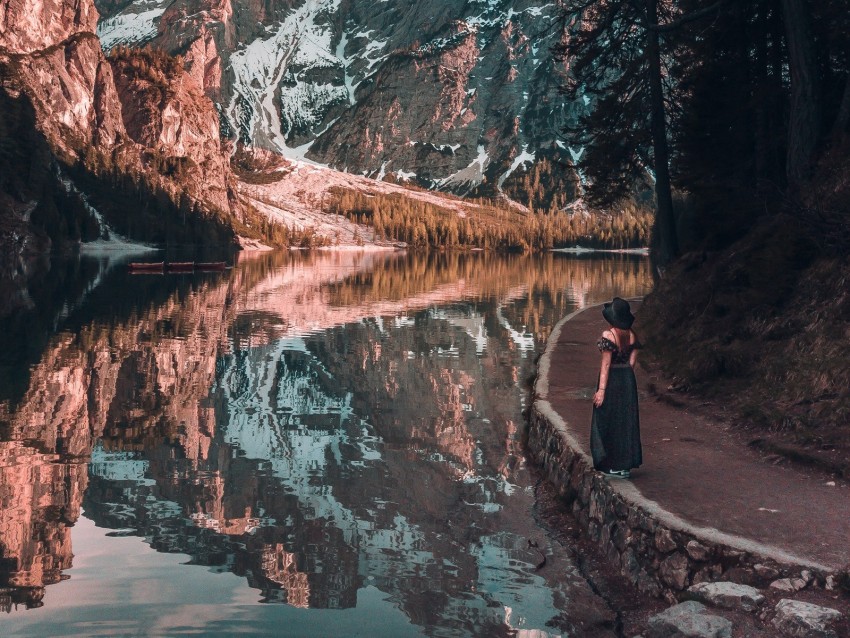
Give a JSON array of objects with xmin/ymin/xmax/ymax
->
[{"xmin": 561, "ymin": 0, "xmax": 850, "ymax": 471}]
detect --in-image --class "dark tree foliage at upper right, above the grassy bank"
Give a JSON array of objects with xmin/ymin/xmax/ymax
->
[{"xmin": 560, "ymin": 0, "xmax": 850, "ymax": 262}]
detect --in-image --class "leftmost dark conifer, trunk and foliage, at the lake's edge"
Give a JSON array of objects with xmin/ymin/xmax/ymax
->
[{"xmin": 559, "ymin": 0, "xmax": 679, "ymax": 266}]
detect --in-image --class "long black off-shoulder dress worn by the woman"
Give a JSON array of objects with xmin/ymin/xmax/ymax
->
[{"xmin": 590, "ymin": 337, "xmax": 643, "ymax": 471}]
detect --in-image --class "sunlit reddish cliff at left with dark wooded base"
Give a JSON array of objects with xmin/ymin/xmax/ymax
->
[{"xmin": 0, "ymin": 0, "xmax": 242, "ymax": 260}]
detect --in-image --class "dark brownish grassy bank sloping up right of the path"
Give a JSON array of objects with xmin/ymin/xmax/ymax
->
[{"xmin": 641, "ymin": 209, "xmax": 850, "ymax": 477}]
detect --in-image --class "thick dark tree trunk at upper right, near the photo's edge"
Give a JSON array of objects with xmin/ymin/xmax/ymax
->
[{"xmin": 782, "ymin": 0, "xmax": 821, "ymax": 191}]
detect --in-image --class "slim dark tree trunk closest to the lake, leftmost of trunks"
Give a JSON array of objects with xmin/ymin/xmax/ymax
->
[{"xmin": 646, "ymin": 0, "xmax": 679, "ymax": 267}]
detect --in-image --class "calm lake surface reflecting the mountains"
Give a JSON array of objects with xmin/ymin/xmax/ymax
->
[{"xmin": 0, "ymin": 253, "xmax": 651, "ymax": 638}]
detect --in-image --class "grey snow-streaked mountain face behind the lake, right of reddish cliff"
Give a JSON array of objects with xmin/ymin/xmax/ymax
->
[{"xmin": 96, "ymin": 0, "xmax": 584, "ymax": 201}]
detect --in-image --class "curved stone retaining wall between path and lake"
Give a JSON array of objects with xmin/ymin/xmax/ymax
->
[{"xmin": 528, "ymin": 408, "xmax": 827, "ymax": 601}]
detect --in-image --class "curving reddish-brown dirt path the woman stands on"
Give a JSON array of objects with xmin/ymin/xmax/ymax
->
[{"xmin": 548, "ymin": 304, "xmax": 850, "ymax": 571}]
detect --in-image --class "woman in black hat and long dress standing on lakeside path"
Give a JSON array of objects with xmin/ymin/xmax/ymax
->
[{"xmin": 590, "ymin": 297, "xmax": 643, "ymax": 478}]
